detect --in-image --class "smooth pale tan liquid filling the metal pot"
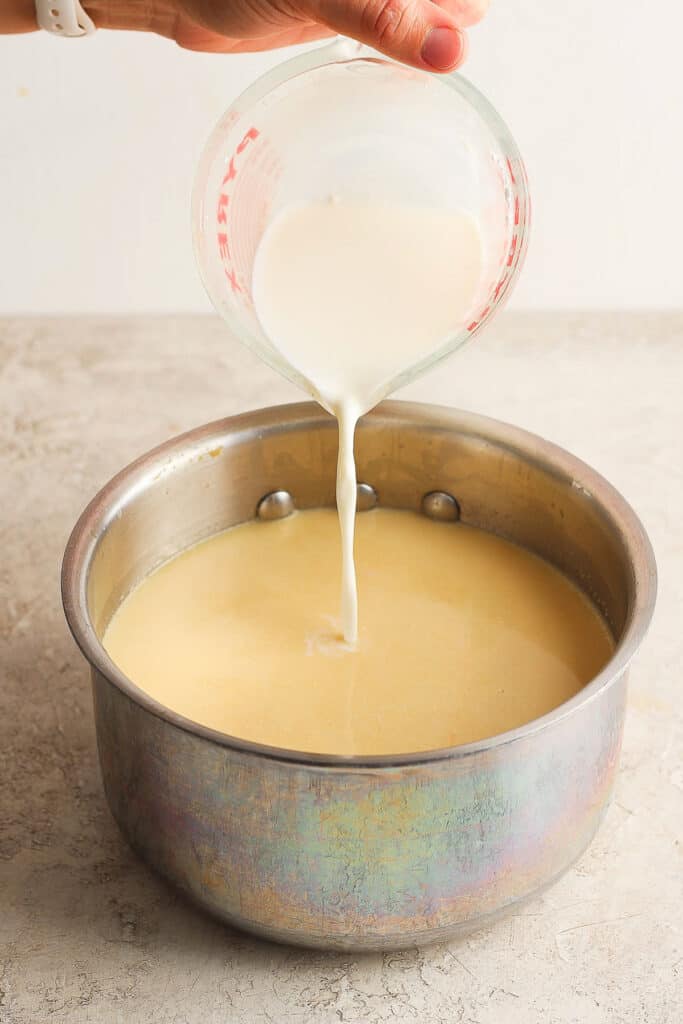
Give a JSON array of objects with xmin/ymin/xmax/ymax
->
[{"xmin": 104, "ymin": 509, "xmax": 612, "ymax": 755}]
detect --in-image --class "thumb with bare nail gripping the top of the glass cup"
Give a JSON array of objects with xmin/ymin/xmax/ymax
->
[{"xmin": 305, "ymin": 0, "xmax": 467, "ymax": 72}]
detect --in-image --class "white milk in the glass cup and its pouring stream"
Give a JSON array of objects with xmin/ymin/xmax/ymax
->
[{"xmin": 252, "ymin": 201, "xmax": 483, "ymax": 644}]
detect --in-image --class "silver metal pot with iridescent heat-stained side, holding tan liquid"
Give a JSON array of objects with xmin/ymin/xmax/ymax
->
[{"xmin": 62, "ymin": 402, "xmax": 656, "ymax": 949}]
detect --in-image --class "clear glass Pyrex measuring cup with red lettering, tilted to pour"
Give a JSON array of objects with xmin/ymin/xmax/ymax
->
[{"xmin": 193, "ymin": 40, "xmax": 529, "ymax": 397}]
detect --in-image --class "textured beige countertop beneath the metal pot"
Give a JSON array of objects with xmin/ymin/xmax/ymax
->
[{"xmin": 0, "ymin": 313, "xmax": 683, "ymax": 1024}]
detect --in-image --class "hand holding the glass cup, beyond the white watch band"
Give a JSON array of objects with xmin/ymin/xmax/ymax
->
[{"xmin": 87, "ymin": 0, "xmax": 488, "ymax": 71}]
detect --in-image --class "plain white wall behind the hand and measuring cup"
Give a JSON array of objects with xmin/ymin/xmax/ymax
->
[{"xmin": 0, "ymin": 0, "xmax": 683, "ymax": 313}]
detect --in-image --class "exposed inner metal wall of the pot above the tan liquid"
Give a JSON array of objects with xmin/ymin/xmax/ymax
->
[{"xmin": 83, "ymin": 402, "xmax": 642, "ymax": 641}]
